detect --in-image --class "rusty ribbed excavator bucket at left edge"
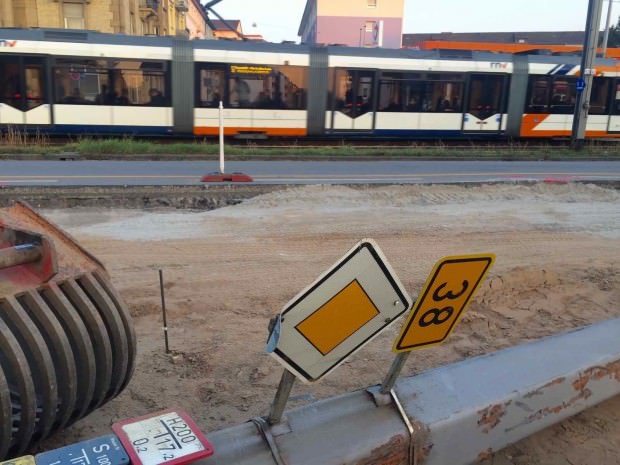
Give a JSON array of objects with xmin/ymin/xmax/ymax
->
[{"xmin": 0, "ymin": 202, "xmax": 136, "ymax": 461}]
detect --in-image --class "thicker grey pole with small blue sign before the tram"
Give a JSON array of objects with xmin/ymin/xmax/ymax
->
[{"xmin": 571, "ymin": 0, "xmax": 603, "ymax": 150}]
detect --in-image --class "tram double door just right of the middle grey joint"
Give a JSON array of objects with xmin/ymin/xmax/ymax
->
[{"xmin": 332, "ymin": 69, "xmax": 375, "ymax": 132}]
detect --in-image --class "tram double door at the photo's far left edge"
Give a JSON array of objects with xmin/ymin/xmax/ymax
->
[{"xmin": 0, "ymin": 56, "xmax": 52, "ymax": 127}]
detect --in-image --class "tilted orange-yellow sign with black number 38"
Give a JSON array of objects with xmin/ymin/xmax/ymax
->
[{"xmin": 393, "ymin": 254, "xmax": 495, "ymax": 352}]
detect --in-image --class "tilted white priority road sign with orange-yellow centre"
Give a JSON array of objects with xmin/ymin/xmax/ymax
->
[{"xmin": 267, "ymin": 239, "xmax": 411, "ymax": 382}]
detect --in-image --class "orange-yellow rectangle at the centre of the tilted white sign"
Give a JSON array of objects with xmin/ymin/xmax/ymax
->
[{"xmin": 295, "ymin": 280, "xmax": 379, "ymax": 355}]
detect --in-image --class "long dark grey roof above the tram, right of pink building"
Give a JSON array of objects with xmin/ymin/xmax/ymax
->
[{"xmin": 403, "ymin": 31, "xmax": 585, "ymax": 47}]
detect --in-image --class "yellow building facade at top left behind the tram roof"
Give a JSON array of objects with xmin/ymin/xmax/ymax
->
[{"xmin": 0, "ymin": 0, "xmax": 193, "ymax": 35}]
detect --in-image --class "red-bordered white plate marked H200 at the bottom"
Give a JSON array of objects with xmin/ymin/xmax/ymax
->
[{"xmin": 112, "ymin": 409, "xmax": 213, "ymax": 465}]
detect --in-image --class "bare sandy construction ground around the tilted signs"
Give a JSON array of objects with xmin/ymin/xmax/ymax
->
[{"xmin": 44, "ymin": 184, "xmax": 620, "ymax": 465}]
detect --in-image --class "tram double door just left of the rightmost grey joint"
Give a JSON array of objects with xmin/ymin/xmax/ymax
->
[{"xmin": 463, "ymin": 74, "xmax": 506, "ymax": 132}]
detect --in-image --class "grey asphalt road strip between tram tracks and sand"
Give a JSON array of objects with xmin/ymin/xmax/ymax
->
[{"xmin": 0, "ymin": 161, "xmax": 620, "ymax": 186}]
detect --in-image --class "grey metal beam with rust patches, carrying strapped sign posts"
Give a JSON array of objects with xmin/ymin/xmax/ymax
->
[{"xmin": 196, "ymin": 319, "xmax": 620, "ymax": 465}]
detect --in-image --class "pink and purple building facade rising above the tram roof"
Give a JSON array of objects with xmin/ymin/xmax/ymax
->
[{"xmin": 298, "ymin": 0, "xmax": 405, "ymax": 48}]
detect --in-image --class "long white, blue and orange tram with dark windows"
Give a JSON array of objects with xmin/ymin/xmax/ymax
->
[{"xmin": 0, "ymin": 29, "xmax": 620, "ymax": 139}]
